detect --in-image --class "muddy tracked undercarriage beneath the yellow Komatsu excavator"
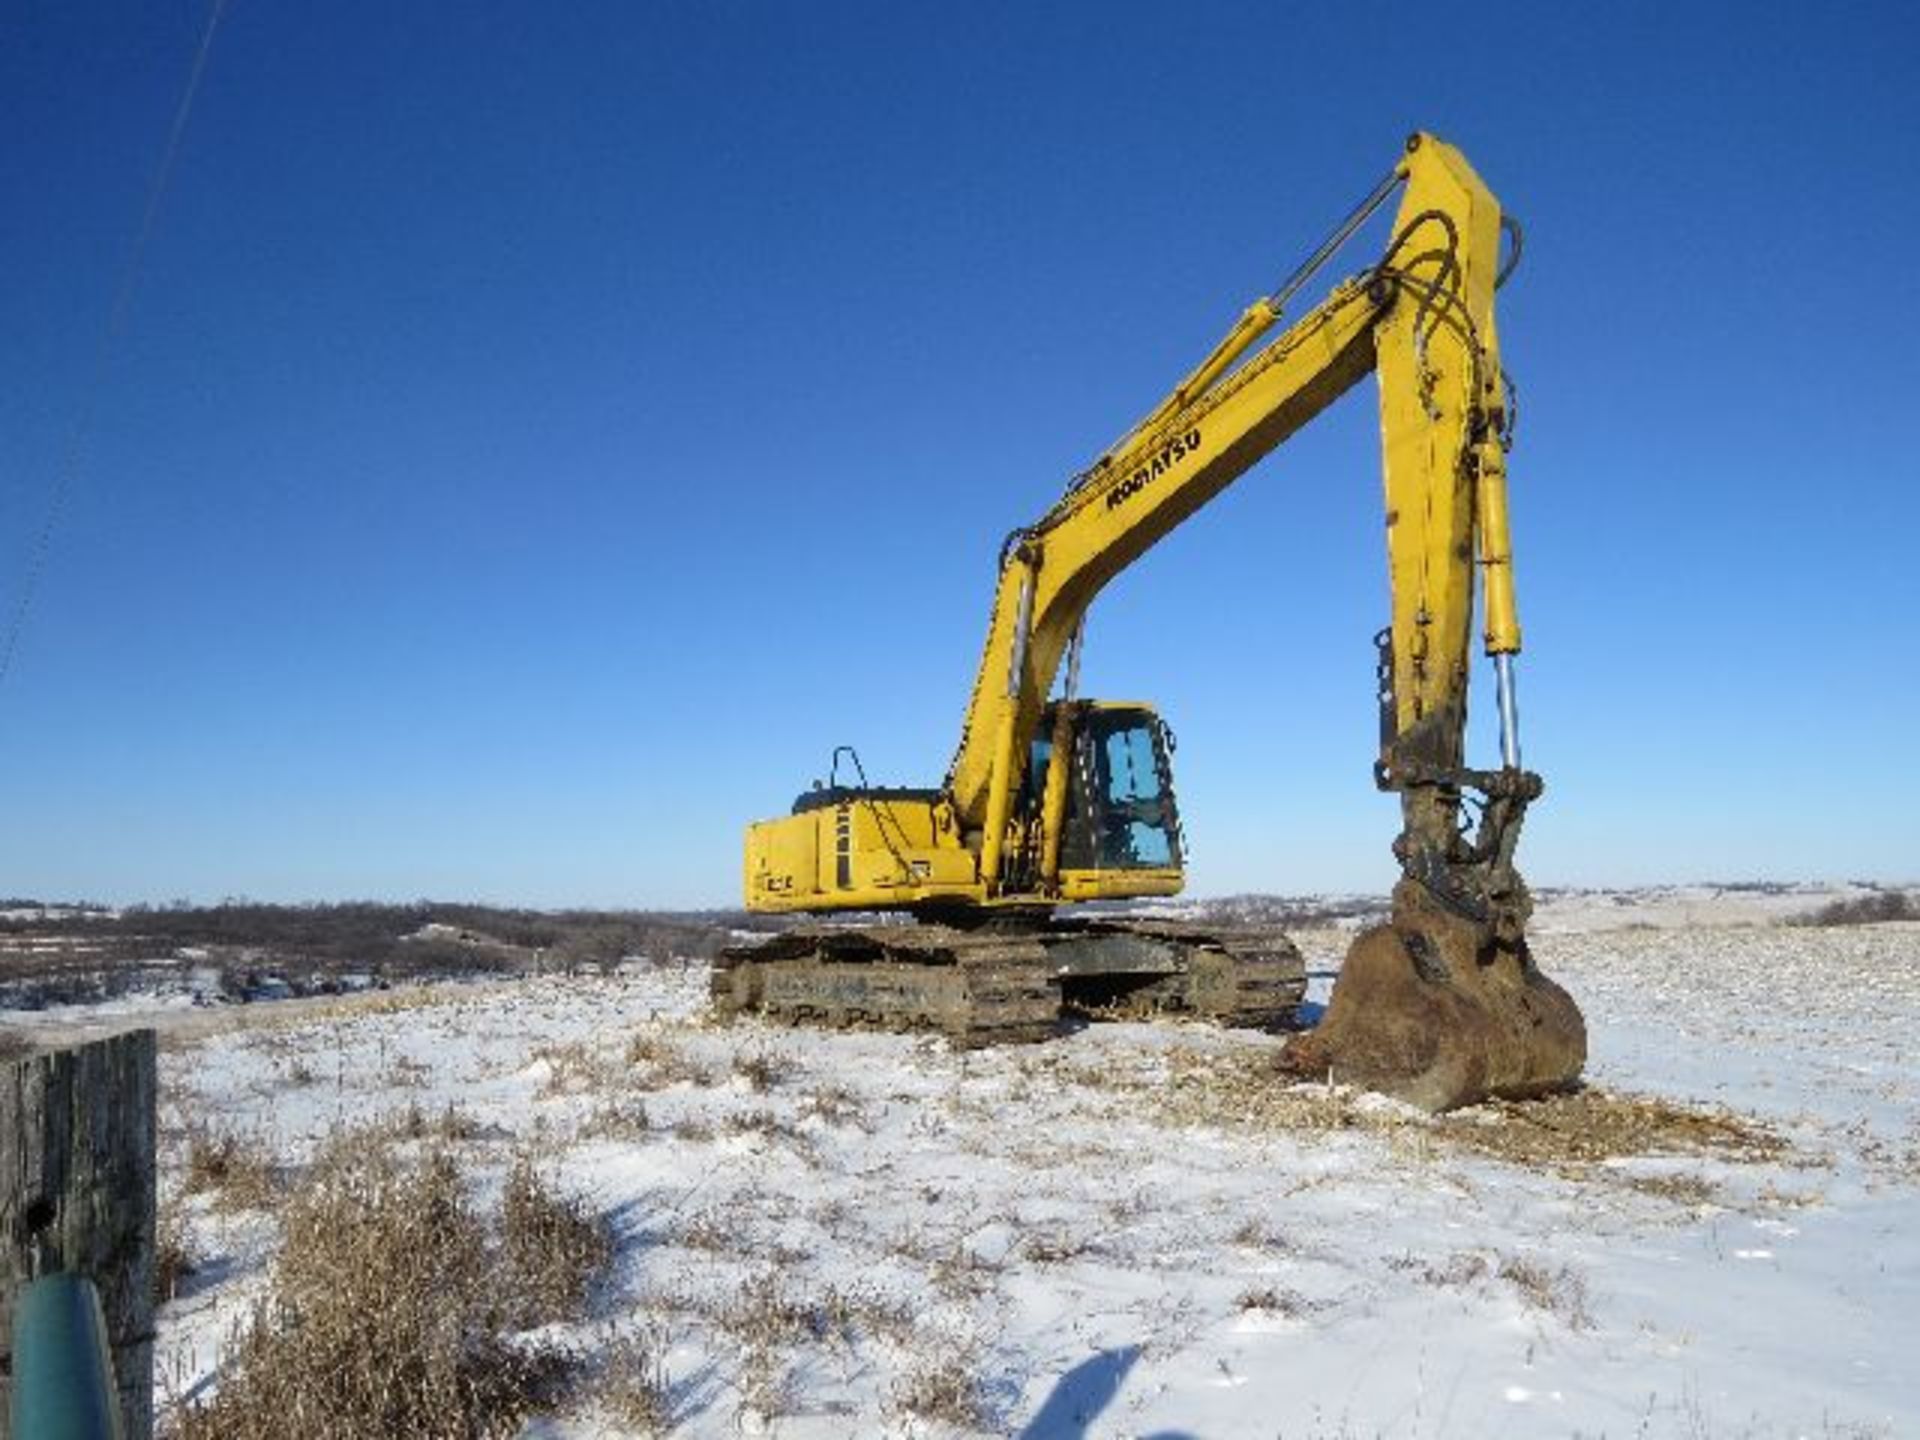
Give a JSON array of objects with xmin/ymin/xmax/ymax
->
[{"xmin": 712, "ymin": 920, "xmax": 1306, "ymax": 1046}]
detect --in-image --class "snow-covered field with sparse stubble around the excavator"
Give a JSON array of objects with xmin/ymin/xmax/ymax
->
[{"xmin": 18, "ymin": 897, "xmax": 1920, "ymax": 1440}]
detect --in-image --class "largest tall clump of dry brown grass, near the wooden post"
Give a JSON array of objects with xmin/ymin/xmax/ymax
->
[{"xmin": 173, "ymin": 1129, "xmax": 605, "ymax": 1440}]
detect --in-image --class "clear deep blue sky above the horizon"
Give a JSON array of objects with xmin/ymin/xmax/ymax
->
[{"xmin": 0, "ymin": 0, "xmax": 1920, "ymax": 906}]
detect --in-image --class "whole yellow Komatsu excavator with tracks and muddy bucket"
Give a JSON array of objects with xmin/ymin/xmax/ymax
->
[{"xmin": 714, "ymin": 134, "xmax": 1586, "ymax": 1110}]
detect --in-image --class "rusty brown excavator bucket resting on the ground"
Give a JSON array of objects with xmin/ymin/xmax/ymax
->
[{"xmin": 1281, "ymin": 881, "xmax": 1586, "ymax": 1112}]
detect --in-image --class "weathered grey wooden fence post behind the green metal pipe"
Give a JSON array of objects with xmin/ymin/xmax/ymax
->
[{"xmin": 0, "ymin": 1029, "xmax": 157, "ymax": 1440}]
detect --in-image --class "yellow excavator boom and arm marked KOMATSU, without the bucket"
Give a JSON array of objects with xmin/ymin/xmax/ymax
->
[{"xmin": 947, "ymin": 134, "xmax": 1540, "ymax": 933}]
